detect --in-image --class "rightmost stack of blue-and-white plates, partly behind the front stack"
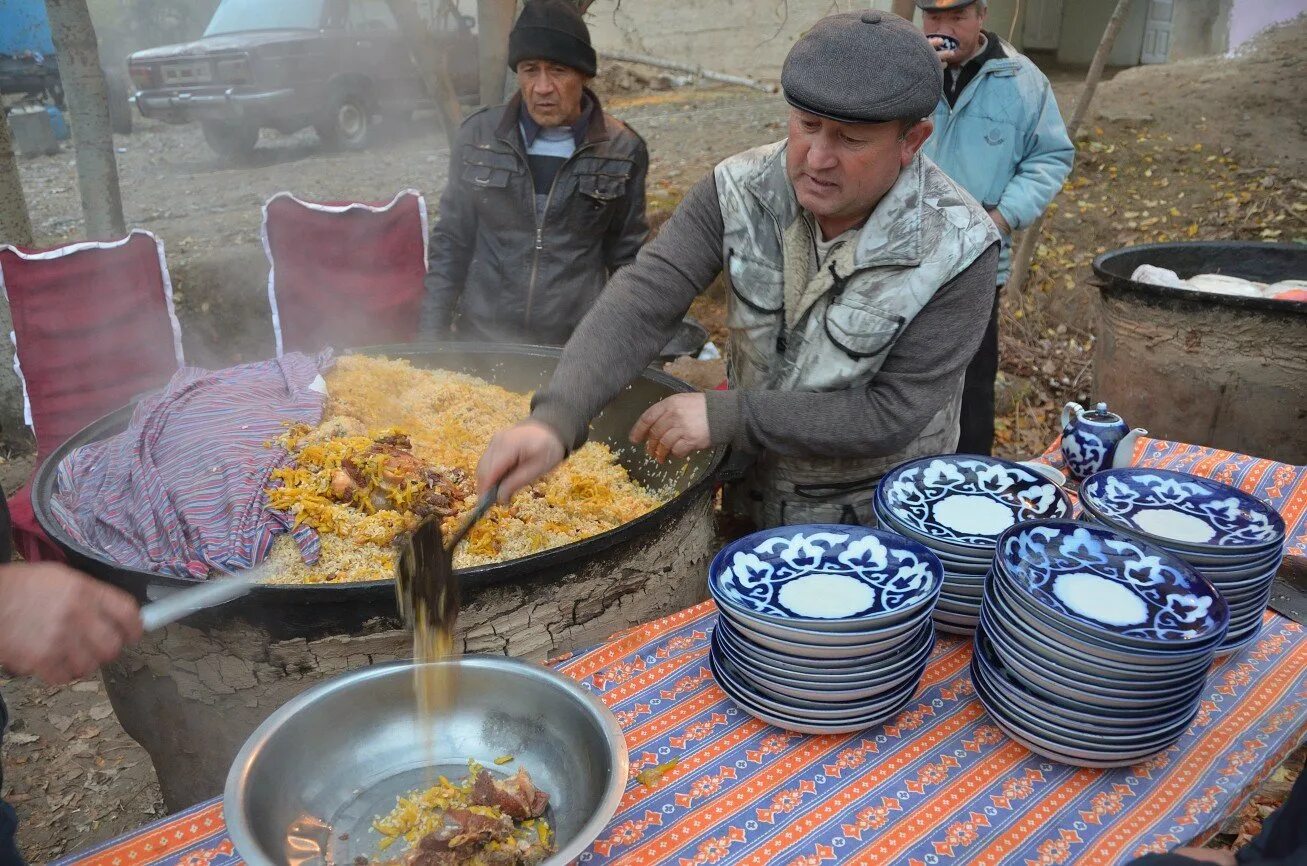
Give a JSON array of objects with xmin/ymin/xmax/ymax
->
[{"xmin": 1080, "ymin": 469, "xmax": 1285, "ymax": 653}]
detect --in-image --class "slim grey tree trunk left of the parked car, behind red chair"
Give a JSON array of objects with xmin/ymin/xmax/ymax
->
[{"xmin": 46, "ymin": 0, "xmax": 127, "ymax": 240}]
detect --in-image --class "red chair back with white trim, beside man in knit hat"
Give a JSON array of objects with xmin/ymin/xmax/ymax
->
[{"xmin": 263, "ymin": 189, "xmax": 426, "ymax": 357}]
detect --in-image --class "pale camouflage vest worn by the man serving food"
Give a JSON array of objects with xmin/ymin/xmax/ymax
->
[{"xmin": 714, "ymin": 141, "xmax": 999, "ymax": 526}]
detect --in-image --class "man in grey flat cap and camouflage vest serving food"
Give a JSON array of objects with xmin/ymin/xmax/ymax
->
[{"xmin": 477, "ymin": 12, "xmax": 999, "ymax": 526}]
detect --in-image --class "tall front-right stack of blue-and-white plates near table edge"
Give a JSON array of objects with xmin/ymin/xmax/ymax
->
[{"xmin": 971, "ymin": 520, "xmax": 1230, "ymax": 767}]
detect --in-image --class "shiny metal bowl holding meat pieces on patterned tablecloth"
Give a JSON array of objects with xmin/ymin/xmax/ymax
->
[{"xmin": 223, "ymin": 656, "xmax": 627, "ymax": 866}]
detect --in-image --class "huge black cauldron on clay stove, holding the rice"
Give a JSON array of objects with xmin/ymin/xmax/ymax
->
[{"xmin": 33, "ymin": 344, "xmax": 721, "ymax": 809}]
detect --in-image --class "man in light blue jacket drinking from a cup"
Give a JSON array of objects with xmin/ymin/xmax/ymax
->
[{"xmin": 916, "ymin": 0, "xmax": 1076, "ymax": 455}]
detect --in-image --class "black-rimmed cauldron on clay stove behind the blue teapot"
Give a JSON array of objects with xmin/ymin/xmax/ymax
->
[{"xmin": 1094, "ymin": 240, "xmax": 1307, "ymax": 464}]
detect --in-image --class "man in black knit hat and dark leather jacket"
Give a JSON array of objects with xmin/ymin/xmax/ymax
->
[{"xmin": 421, "ymin": 0, "xmax": 648, "ymax": 345}]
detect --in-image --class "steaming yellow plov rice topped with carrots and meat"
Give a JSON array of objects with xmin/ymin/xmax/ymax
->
[{"xmin": 268, "ymin": 355, "xmax": 661, "ymax": 583}]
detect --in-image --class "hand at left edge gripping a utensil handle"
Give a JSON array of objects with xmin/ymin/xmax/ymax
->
[{"xmin": 0, "ymin": 563, "xmax": 141, "ymax": 686}]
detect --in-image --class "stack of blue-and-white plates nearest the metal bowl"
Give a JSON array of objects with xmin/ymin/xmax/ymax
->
[{"xmin": 708, "ymin": 525, "xmax": 942, "ymax": 734}]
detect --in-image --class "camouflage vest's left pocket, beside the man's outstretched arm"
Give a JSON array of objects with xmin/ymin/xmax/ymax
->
[{"xmin": 727, "ymin": 249, "xmax": 786, "ymax": 385}]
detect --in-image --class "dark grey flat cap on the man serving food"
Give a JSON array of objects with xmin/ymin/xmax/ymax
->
[{"xmin": 780, "ymin": 9, "xmax": 944, "ymax": 123}]
